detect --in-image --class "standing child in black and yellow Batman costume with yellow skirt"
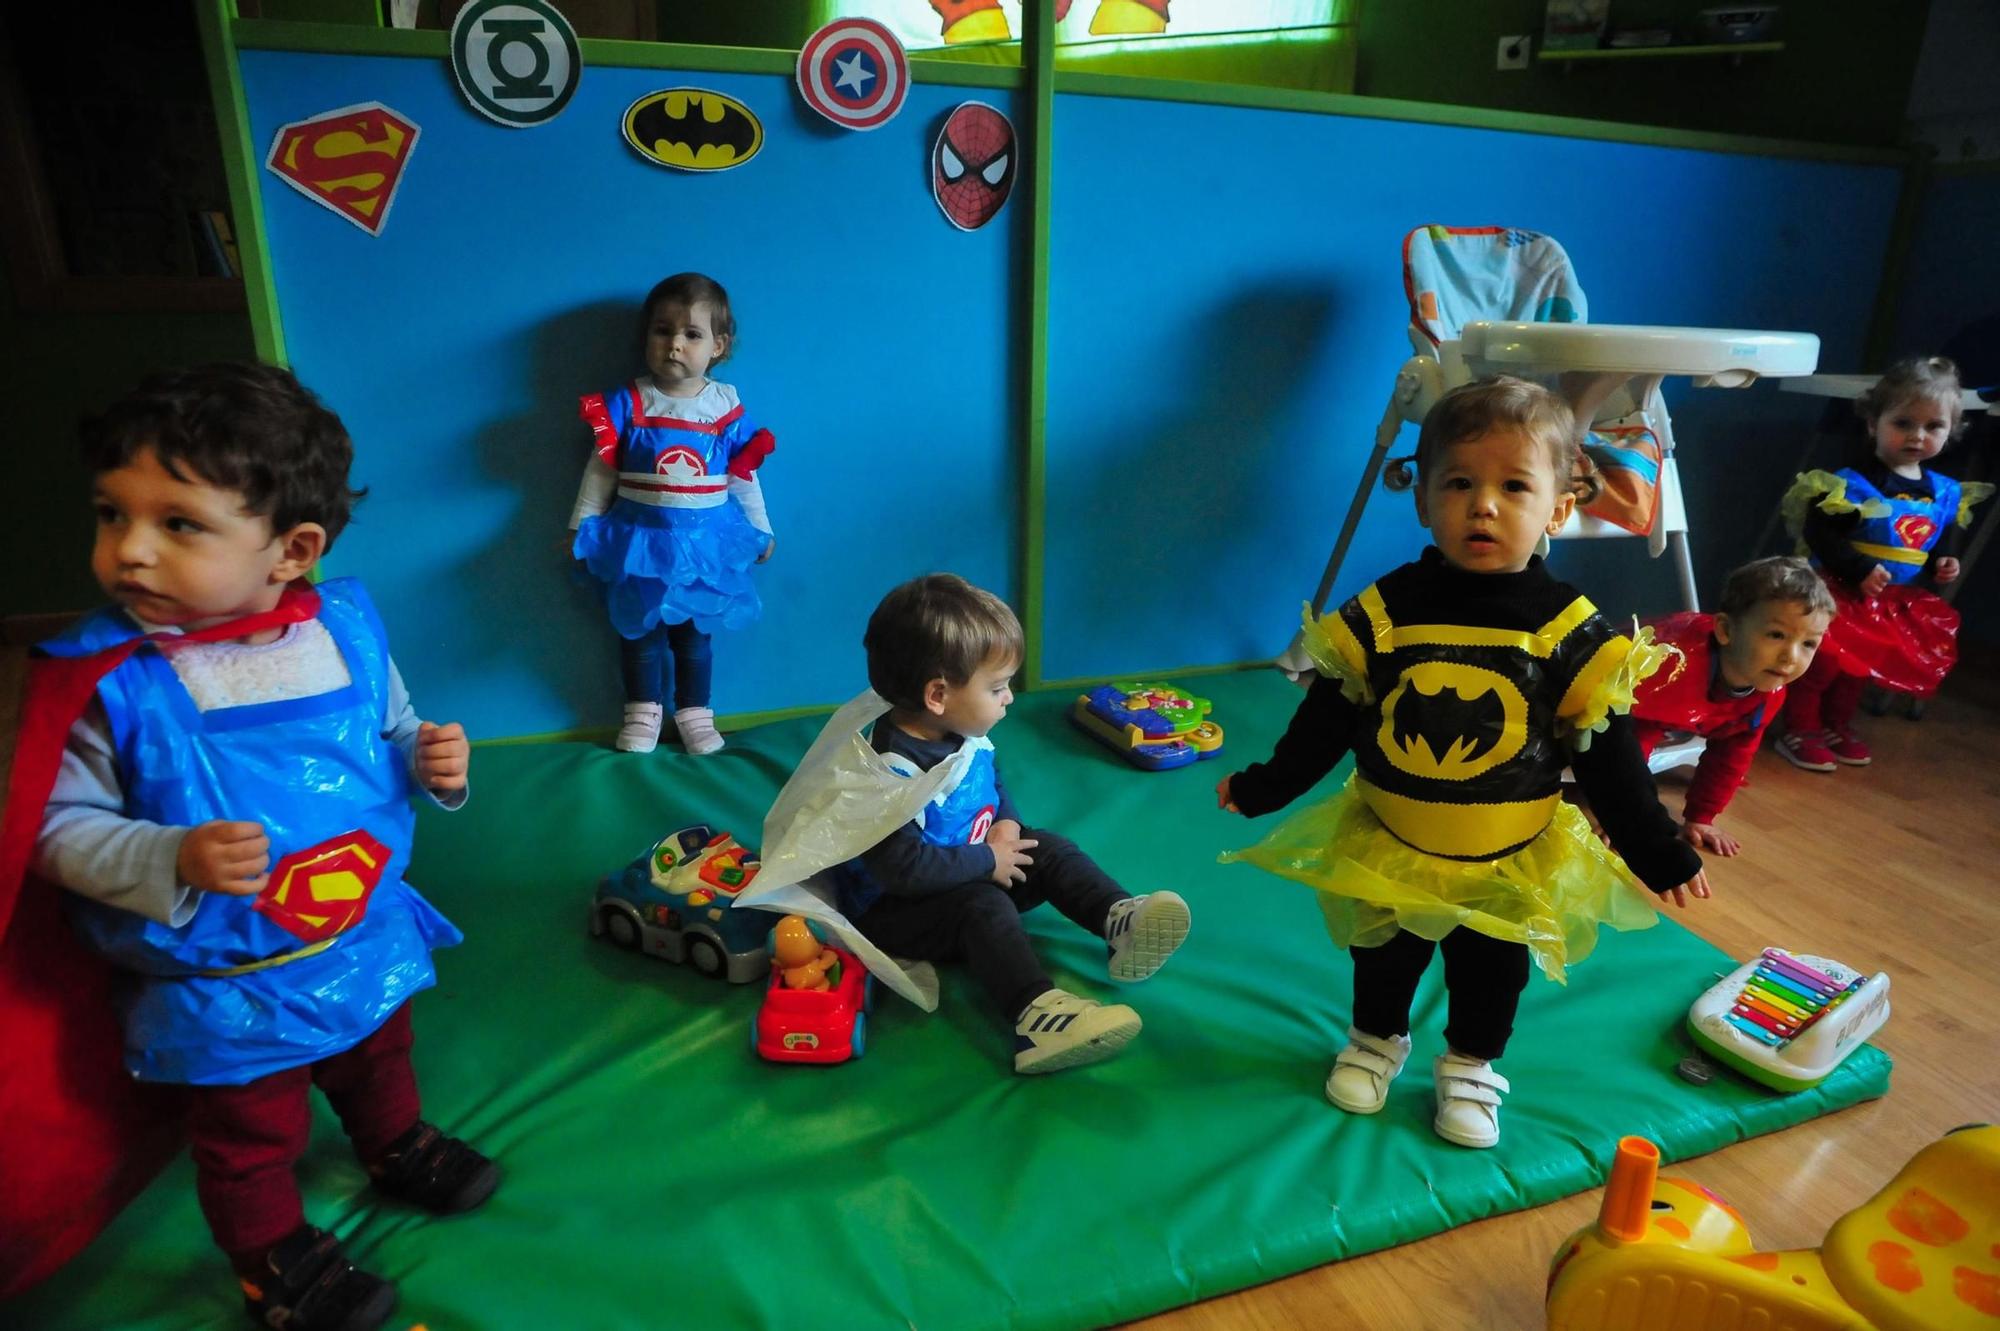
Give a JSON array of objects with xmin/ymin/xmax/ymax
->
[{"xmin": 1216, "ymin": 378, "xmax": 1708, "ymax": 1147}]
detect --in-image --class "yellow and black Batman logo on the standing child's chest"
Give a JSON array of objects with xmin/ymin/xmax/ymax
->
[{"xmin": 1376, "ymin": 662, "xmax": 1528, "ymax": 781}]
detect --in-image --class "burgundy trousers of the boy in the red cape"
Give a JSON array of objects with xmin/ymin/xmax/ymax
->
[{"xmin": 188, "ymin": 1003, "xmax": 418, "ymax": 1271}]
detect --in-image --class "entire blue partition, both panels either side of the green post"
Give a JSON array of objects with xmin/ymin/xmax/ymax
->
[{"xmin": 242, "ymin": 50, "xmax": 1898, "ymax": 735}]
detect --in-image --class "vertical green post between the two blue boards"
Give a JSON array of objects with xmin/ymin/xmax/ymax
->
[{"xmin": 1020, "ymin": 0, "xmax": 1056, "ymax": 689}]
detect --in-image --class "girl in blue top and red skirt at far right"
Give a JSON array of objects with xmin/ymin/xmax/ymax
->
[{"xmin": 1776, "ymin": 356, "xmax": 1994, "ymax": 771}]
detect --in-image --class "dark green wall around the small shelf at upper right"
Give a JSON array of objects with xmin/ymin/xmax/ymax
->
[{"xmin": 1356, "ymin": 0, "xmax": 1930, "ymax": 147}]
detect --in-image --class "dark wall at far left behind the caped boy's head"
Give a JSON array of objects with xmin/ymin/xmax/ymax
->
[{"xmin": 0, "ymin": 286, "xmax": 252, "ymax": 616}]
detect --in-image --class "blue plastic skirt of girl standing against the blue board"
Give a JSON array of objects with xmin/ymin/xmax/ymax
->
[{"xmin": 572, "ymin": 500, "xmax": 770, "ymax": 638}]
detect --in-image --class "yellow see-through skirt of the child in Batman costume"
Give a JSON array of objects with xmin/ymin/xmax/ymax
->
[{"xmin": 1222, "ymin": 775, "xmax": 1658, "ymax": 983}]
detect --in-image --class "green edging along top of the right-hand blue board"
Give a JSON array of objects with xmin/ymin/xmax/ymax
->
[{"xmin": 1056, "ymin": 70, "xmax": 1910, "ymax": 166}]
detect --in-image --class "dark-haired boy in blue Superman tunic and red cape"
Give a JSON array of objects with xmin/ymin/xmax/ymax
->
[{"xmin": 0, "ymin": 366, "xmax": 500, "ymax": 1331}]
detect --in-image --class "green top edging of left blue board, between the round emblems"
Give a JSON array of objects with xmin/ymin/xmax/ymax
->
[{"xmin": 236, "ymin": 18, "xmax": 1022, "ymax": 88}]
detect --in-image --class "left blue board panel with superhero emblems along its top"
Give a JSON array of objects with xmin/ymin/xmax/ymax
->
[{"xmin": 242, "ymin": 50, "xmax": 1020, "ymax": 735}]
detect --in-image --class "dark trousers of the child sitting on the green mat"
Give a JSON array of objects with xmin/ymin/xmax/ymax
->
[{"xmin": 854, "ymin": 829, "xmax": 1132, "ymax": 1025}]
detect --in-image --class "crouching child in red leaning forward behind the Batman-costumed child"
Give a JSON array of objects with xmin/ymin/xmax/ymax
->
[{"xmin": 1632, "ymin": 556, "xmax": 1834, "ymax": 855}]
